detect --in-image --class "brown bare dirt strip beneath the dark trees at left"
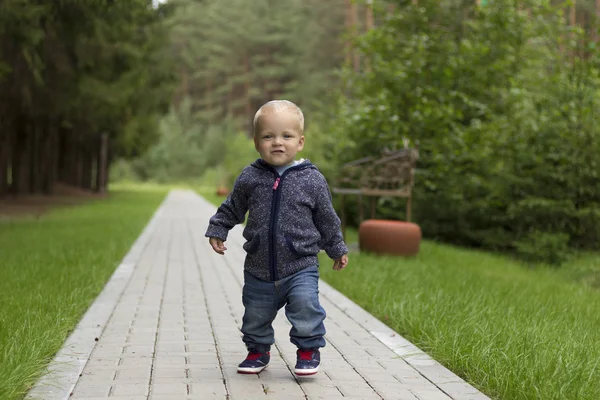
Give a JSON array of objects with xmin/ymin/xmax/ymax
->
[{"xmin": 0, "ymin": 184, "xmax": 106, "ymax": 219}]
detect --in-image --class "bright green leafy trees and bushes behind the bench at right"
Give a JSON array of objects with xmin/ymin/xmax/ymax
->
[{"xmin": 333, "ymin": 0, "xmax": 600, "ymax": 262}]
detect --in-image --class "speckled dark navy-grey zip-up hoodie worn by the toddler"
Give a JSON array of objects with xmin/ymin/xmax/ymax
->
[{"xmin": 205, "ymin": 159, "xmax": 348, "ymax": 281}]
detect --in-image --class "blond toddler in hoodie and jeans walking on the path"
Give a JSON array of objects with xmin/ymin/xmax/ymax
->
[{"xmin": 206, "ymin": 100, "xmax": 348, "ymax": 375}]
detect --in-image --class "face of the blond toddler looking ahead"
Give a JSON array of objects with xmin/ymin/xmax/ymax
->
[{"xmin": 254, "ymin": 111, "xmax": 304, "ymax": 167}]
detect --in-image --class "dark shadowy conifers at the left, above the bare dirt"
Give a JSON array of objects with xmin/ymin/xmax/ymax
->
[{"xmin": 0, "ymin": 0, "xmax": 174, "ymax": 196}]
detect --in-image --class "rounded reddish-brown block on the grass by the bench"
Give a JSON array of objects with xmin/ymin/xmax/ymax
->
[{"xmin": 358, "ymin": 219, "xmax": 421, "ymax": 257}]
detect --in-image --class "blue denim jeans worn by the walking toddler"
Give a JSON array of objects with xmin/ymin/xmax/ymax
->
[{"xmin": 242, "ymin": 267, "xmax": 325, "ymax": 353}]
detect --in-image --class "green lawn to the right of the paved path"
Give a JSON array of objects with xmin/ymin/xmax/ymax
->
[{"xmin": 196, "ymin": 188, "xmax": 600, "ymax": 400}]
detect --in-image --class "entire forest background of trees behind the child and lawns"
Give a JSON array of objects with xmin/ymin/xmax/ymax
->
[{"xmin": 0, "ymin": 0, "xmax": 600, "ymax": 264}]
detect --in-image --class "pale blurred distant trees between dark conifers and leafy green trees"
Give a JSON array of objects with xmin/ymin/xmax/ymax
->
[{"xmin": 114, "ymin": 0, "xmax": 366, "ymax": 181}]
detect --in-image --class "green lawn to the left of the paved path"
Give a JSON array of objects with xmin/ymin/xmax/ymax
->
[{"xmin": 0, "ymin": 186, "xmax": 166, "ymax": 400}]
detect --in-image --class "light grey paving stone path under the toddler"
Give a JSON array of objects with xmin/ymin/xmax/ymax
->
[{"xmin": 26, "ymin": 190, "xmax": 487, "ymax": 400}]
